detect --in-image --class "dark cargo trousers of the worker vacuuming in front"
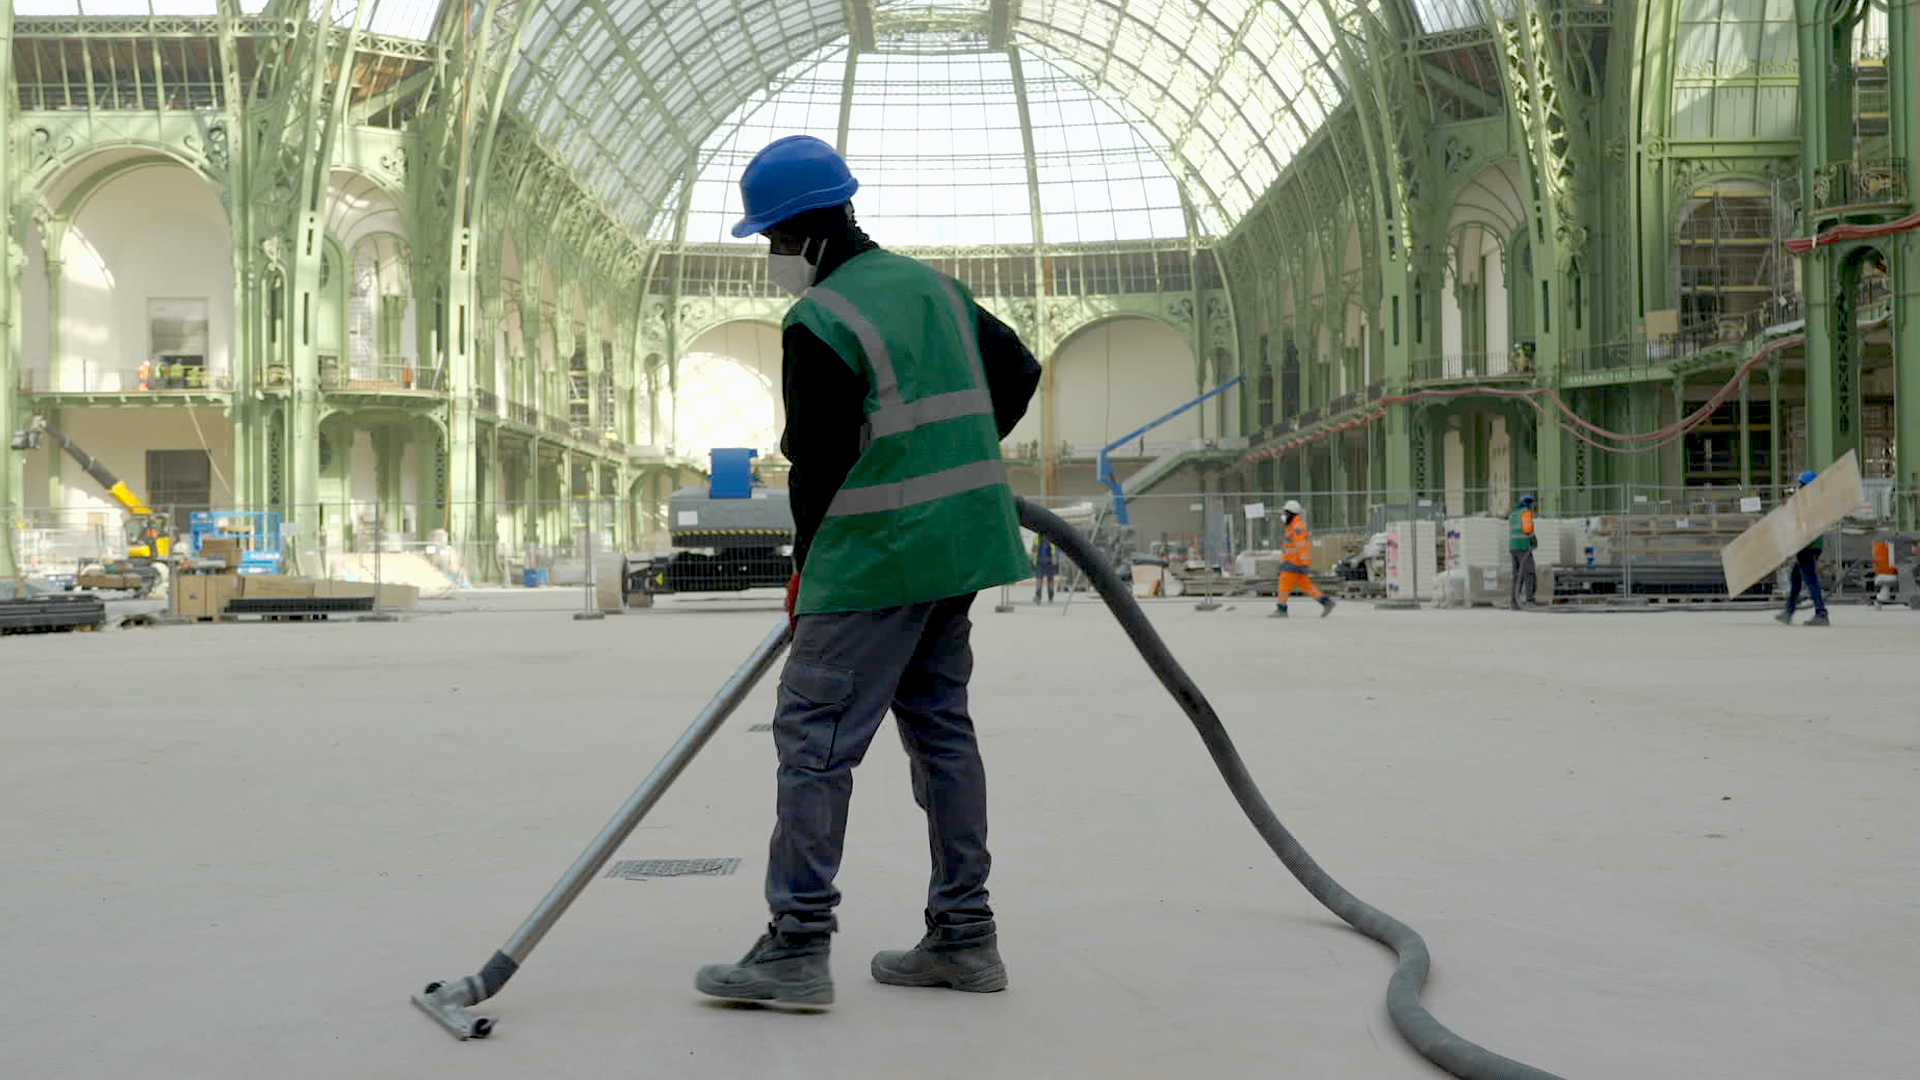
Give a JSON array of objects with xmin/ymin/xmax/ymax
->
[{"xmin": 766, "ymin": 594, "xmax": 993, "ymax": 934}]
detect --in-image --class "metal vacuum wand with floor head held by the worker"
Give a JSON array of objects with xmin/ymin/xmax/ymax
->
[{"xmin": 413, "ymin": 619, "xmax": 793, "ymax": 1040}]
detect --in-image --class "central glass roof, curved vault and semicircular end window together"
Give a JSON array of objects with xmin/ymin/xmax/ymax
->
[{"xmin": 509, "ymin": 0, "xmax": 1342, "ymax": 244}]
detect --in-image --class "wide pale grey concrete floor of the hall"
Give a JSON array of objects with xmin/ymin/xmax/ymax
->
[{"xmin": 0, "ymin": 592, "xmax": 1920, "ymax": 1080}]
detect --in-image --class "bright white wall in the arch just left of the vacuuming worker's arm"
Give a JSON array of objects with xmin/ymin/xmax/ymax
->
[{"xmin": 679, "ymin": 323, "xmax": 787, "ymax": 459}]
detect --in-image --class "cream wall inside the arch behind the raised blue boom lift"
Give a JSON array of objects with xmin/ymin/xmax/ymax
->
[{"xmin": 1008, "ymin": 319, "xmax": 1212, "ymax": 457}]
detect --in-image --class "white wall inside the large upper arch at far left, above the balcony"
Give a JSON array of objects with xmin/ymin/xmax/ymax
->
[{"xmin": 56, "ymin": 165, "xmax": 234, "ymax": 390}]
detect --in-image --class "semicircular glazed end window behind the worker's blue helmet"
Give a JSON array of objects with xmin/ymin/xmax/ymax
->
[{"xmin": 675, "ymin": 44, "xmax": 1188, "ymax": 248}]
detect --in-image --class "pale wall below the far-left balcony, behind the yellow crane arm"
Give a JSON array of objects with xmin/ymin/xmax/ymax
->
[{"xmin": 27, "ymin": 407, "xmax": 234, "ymax": 511}]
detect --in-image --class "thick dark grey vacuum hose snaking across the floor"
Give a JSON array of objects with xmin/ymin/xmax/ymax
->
[{"xmin": 1018, "ymin": 500, "xmax": 1559, "ymax": 1080}]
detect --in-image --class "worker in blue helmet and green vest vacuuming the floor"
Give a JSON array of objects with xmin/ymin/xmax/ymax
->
[{"xmin": 695, "ymin": 136, "xmax": 1041, "ymax": 1005}]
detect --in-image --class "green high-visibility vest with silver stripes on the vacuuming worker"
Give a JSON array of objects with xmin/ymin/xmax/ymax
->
[{"xmin": 785, "ymin": 250, "xmax": 1031, "ymax": 615}]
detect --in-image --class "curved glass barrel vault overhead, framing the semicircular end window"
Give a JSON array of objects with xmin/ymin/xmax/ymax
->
[{"xmin": 511, "ymin": 0, "xmax": 1342, "ymax": 240}]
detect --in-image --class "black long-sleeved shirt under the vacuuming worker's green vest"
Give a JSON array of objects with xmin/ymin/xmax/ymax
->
[{"xmin": 780, "ymin": 255, "xmax": 1041, "ymax": 569}]
